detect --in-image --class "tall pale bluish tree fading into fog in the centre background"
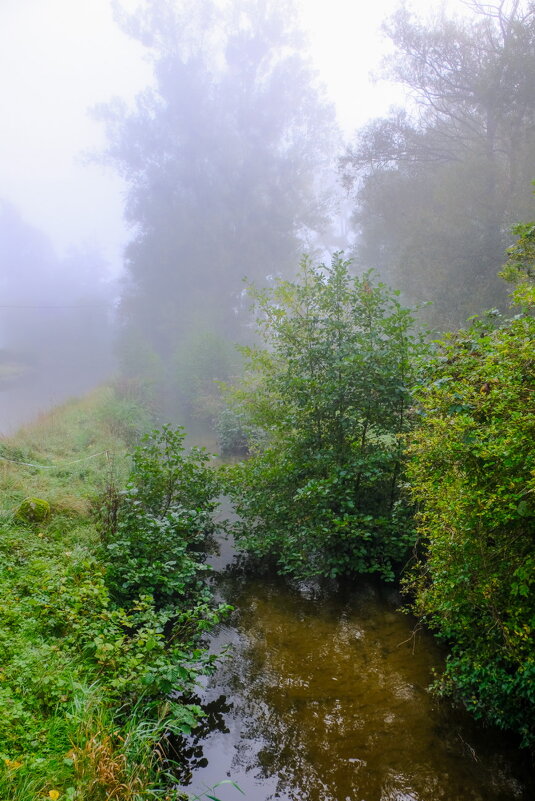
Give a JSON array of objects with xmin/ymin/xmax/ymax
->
[{"xmin": 101, "ymin": 0, "xmax": 336, "ymax": 410}]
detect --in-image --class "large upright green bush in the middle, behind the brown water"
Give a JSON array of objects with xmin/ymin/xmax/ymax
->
[{"xmin": 227, "ymin": 256, "xmax": 426, "ymax": 580}]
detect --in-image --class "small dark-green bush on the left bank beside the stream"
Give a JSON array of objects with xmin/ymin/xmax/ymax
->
[{"xmin": 103, "ymin": 426, "xmax": 217, "ymax": 607}]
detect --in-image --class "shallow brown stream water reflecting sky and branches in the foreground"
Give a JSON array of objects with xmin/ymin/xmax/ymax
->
[{"xmin": 175, "ymin": 548, "xmax": 533, "ymax": 801}]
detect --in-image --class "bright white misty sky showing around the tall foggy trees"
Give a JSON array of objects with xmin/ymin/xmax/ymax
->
[{"xmin": 0, "ymin": 0, "xmax": 464, "ymax": 272}]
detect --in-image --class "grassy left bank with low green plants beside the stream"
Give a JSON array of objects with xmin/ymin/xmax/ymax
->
[{"xmin": 0, "ymin": 388, "xmax": 226, "ymax": 801}]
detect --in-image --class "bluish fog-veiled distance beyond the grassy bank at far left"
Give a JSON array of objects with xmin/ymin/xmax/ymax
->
[{"xmin": 0, "ymin": 202, "xmax": 118, "ymax": 430}]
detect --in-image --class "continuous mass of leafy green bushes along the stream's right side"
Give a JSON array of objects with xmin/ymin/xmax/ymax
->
[{"xmin": 219, "ymin": 252, "xmax": 535, "ymax": 748}]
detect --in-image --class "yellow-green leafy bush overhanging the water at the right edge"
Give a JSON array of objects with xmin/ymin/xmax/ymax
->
[{"xmin": 409, "ymin": 304, "xmax": 535, "ymax": 744}]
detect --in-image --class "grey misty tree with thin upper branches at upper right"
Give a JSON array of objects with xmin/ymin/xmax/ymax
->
[{"xmin": 343, "ymin": 0, "xmax": 535, "ymax": 326}]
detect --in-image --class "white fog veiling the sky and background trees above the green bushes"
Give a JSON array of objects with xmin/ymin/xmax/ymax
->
[{"xmin": 0, "ymin": 0, "xmax": 535, "ymax": 432}]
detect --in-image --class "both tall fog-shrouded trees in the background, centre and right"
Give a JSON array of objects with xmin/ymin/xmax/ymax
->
[{"xmin": 99, "ymin": 0, "xmax": 535, "ymax": 418}]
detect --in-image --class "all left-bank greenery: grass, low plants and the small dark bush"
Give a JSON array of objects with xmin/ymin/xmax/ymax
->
[{"xmin": 0, "ymin": 390, "xmax": 226, "ymax": 801}]
